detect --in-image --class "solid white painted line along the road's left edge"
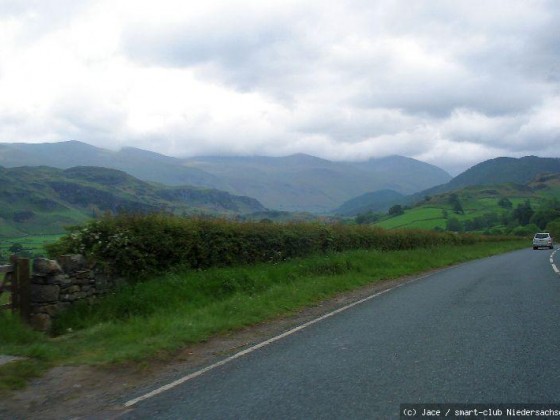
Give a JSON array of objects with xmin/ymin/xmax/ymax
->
[{"xmin": 124, "ymin": 273, "xmax": 432, "ymax": 407}]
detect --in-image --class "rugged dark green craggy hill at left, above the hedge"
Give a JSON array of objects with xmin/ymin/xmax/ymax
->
[{"xmin": 0, "ymin": 166, "xmax": 266, "ymax": 237}]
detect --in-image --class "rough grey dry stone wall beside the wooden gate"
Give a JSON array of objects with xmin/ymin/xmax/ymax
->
[{"xmin": 29, "ymin": 255, "xmax": 123, "ymax": 331}]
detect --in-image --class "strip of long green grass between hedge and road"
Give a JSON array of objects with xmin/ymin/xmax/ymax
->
[{"xmin": 0, "ymin": 241, "xmax": 526, "ymax": 389}]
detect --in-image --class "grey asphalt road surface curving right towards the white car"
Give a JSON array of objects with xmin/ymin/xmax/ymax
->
[{"xmin": 123, "ymin": 249, "xmax": 560, "ymax": 419}]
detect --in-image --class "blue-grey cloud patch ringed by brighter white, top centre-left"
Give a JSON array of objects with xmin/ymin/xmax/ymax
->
[{"xmin": 123, "ymin": 11, "xmax": 314, "ymax": 94}]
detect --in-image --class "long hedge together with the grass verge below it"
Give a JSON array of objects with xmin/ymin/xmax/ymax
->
[{"xmin": 0, "ymin": 215, "xmax": 527, "ymax": 389}]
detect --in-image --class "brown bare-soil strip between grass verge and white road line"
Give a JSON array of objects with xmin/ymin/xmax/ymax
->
[{"xmin": 0, "ymin": 277, "xmax": 428, "ymax": 419}]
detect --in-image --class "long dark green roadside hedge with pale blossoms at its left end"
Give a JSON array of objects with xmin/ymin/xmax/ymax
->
[{"xmin": 48, "ymin": 214, "xmax": 510, "ymax": 277}]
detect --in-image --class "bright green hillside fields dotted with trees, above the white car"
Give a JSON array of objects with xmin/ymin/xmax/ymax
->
[{"xmin": 375, "ymin": 174, "xmax": 560, "ymax": 233}]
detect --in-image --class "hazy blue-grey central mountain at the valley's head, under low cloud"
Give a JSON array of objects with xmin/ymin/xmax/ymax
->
[{"xmin": 185, "ymin": 154, "xmax": 451, "ymax": 213}]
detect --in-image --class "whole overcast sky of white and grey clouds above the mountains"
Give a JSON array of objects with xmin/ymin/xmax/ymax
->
[{"xmin": 0, "ymin": 0, "xmax": 560, "ymax": 174}]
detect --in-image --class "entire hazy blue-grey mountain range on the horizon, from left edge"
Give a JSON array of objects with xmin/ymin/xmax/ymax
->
[{"xmin": 0, "ymin": 141, "xmax": 451, "ymax": 213}]
